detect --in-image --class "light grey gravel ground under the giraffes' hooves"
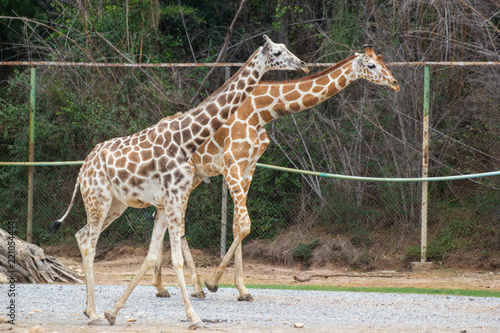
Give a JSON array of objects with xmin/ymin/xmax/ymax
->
[{"xmin": 0, "ymin": 284, "xmax": 500, "ymax": 332}]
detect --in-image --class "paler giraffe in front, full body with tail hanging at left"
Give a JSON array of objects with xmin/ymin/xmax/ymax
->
[{"xmin": 52, "ymin": 35, "xmax": 309, "ymax": 328}]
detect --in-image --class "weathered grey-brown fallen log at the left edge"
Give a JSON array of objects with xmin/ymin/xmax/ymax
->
[{"xmin": 0, "ymin": 229, "xmax": 83, "ymax": 283}]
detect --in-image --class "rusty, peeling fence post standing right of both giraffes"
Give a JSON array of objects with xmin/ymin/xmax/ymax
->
[{"xmin": 420, "ymin": 66, "xmax": 430, "ymax": 262}]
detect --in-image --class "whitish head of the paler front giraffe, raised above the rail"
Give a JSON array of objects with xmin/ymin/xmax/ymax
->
[{"xmin": 261, "ymin": 35, "xmax": 309, "ymax": 73}]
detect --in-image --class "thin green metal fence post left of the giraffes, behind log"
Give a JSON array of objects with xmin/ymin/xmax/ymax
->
[{"xmin": 26, "ymin": 67, "xmax": 36, "ymax": 243}]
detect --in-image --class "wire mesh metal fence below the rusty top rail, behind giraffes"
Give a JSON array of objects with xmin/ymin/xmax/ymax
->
[{"xmin": 0, "ymin": 63, "xmax": 500, "ymax": 266}]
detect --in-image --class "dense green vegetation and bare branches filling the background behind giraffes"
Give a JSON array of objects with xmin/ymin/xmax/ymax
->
[{"xmin": 0, "ymin": 0, "xmax": 500, "ymax": 261}]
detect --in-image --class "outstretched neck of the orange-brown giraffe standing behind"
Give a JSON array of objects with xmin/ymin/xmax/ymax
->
[{"xmin": 244, "ymin": 56, "xmax": 358, "ymax": 126}]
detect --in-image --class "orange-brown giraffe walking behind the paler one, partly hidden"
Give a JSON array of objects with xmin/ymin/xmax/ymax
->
[{"xmin": 154, "ymin": 45, "xmax": 400, "ymax": 301}]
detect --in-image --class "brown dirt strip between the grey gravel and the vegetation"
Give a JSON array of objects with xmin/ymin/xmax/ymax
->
[{"xmin": 46, "ymin": 246, "xmax": 500, "ymax": 291}]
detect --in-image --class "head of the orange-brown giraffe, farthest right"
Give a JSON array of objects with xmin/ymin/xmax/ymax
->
[{"xmin": 353, "ymin": 45, "xmax": 400, "ymax": 92}]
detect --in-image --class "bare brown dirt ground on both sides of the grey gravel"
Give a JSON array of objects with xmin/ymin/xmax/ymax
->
[{"xmin": 4, "ymin": 246, "xmax": 500, "ymax": 333}]
